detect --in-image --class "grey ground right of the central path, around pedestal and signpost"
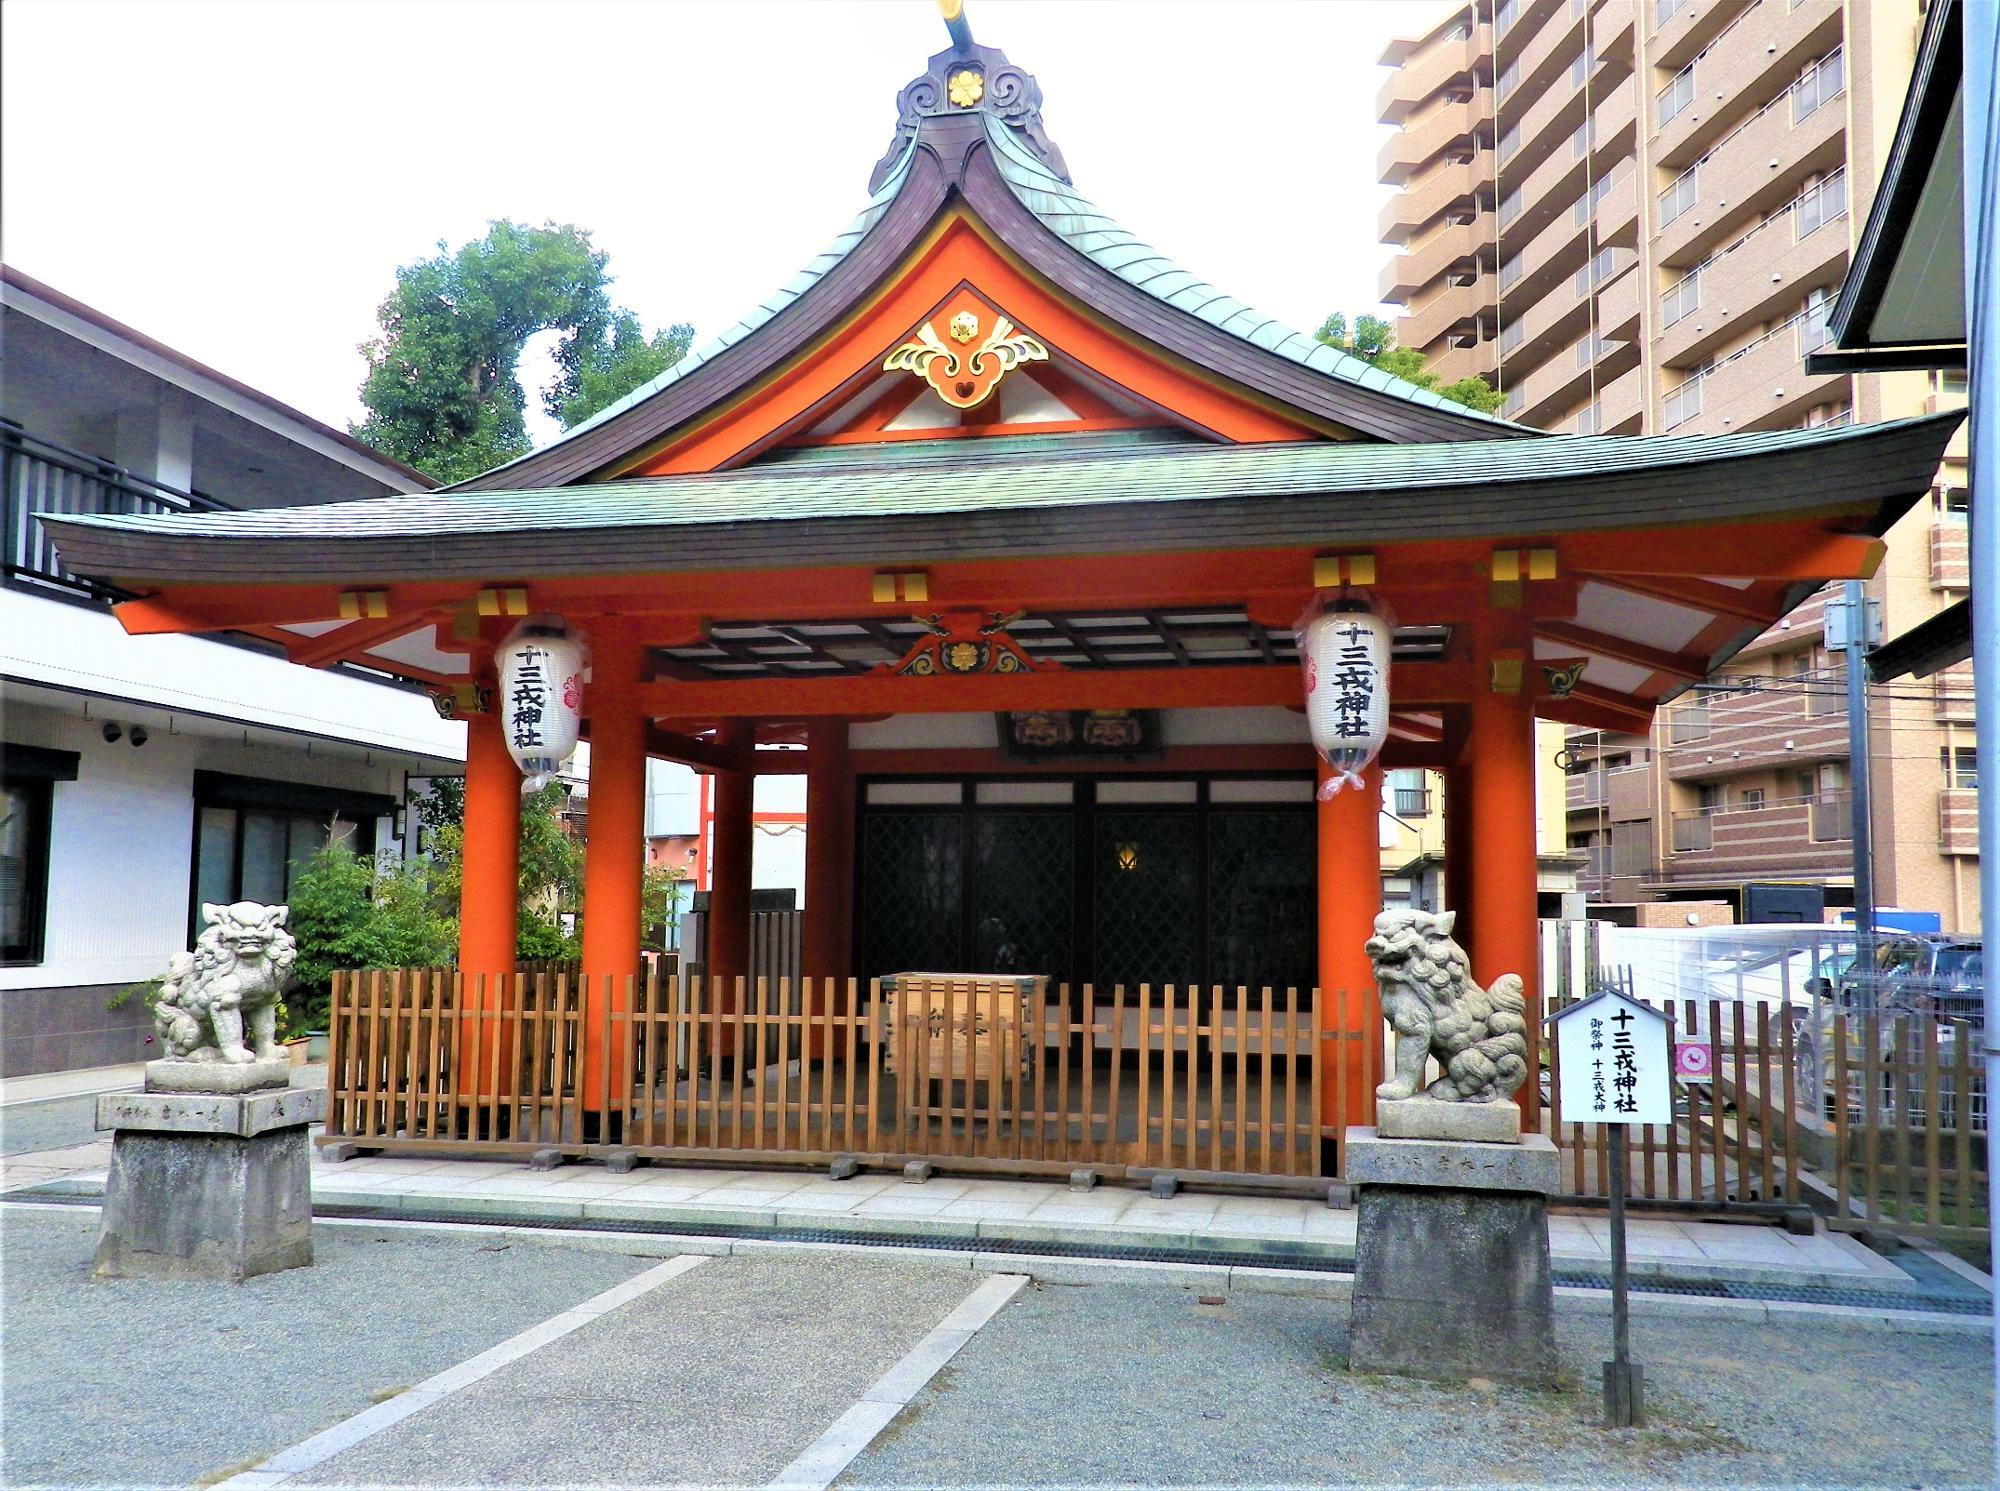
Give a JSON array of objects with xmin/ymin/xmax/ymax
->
[{"xmin": 836, "ymin": 1283, "xmax": 1994, "ymax": 1487}]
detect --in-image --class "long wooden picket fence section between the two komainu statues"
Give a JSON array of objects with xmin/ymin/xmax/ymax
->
[{"xmin": 326, "ymin": 969, "xmax": 1380, "ymax": 1177}]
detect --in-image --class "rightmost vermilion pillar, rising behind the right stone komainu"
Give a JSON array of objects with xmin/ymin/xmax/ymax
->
[{"xmin": 1464, "ymin": 652, "xmax": 1542, "ymax": 1131}]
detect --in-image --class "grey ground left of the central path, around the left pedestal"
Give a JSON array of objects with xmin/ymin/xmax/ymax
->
[{"xmin": 0, "ymin": 1207, "xmax": 658, "ymax": 1487}]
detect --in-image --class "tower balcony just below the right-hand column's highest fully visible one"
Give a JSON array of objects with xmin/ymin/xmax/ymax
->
[{"xmin": 1656, "ymin": 172, "xmax": 1848, "ymax": 368}]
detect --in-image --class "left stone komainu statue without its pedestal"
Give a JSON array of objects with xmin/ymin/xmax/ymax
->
[{"xmin": 152, "ymin": 901, "xmax": 298, "ymax": 1065}]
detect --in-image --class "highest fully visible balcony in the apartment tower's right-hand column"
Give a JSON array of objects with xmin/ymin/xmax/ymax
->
[{"xmin": 1654, "ymin": 61, "xmax": 1846, "ymax": 268}]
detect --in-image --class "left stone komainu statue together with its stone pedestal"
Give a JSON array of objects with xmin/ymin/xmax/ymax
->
[{"xmin": 92, "ymin": 901, "xmax": 326, "ymax": 1281}]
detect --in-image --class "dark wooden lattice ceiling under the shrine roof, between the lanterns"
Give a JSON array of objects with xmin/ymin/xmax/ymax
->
[{"xmin": 654, "ymin": 608, "xmax": 1450, "ymax": 678}]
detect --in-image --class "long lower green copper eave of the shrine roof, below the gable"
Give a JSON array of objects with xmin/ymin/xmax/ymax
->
[{"xmin": 44, "ymin": 416, "xmax": 1956, "ymax": 539}]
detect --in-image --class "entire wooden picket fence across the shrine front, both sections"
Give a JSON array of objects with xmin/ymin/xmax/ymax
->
[{"xmin": 326, "ymin": 959, "xmax": 1988, "ymax": 1239}]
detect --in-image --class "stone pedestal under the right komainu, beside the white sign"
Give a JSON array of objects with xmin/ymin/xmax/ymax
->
[{"xmin": 1348, "ymin": 1127, "xmax": 1558, "ymax": 1387}]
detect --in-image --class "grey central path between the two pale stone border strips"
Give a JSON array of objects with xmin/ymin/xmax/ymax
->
[{"xmin": 296, "ymin": 1253, "xmax": 992, "ymax": 1487}]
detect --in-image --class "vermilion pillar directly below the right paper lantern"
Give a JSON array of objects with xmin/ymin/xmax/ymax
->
[{"xmin": 1318, "ymin": 761, "xmax": 1382, "ymax": 1127}]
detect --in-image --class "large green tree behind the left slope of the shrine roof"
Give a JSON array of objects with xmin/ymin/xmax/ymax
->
[{"xmin": 354, "ymin": 218, "xmax": 692, "ymax": 482}]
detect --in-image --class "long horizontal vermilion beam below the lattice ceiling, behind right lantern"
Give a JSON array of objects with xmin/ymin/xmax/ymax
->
[{"xmin": 638, "ymin": 664, "xmax": 1474, "ymax": 720}]
